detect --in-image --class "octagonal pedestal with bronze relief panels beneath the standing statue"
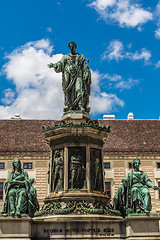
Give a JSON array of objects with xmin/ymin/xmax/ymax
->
[{"xmin": 41, "ymin": 113, "xmax": 109, "ymax": 215}]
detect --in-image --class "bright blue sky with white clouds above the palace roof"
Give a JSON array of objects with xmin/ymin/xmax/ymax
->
[{"xmin": 0, "ymin": 0, "xmax": 160, "ymax": 119}]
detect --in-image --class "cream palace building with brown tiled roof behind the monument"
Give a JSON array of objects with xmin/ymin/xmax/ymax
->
[{"xmin": 0, "ymin": 118, "xmax": 160, "ymax": 214}]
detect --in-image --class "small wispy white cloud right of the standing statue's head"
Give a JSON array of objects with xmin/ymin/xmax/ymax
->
[{"xmin": 102, "ymin": 40, "xmax": 152, "ymax": 63}]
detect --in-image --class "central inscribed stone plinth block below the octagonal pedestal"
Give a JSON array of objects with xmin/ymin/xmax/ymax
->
[{"xmin": 32, "ymin": 215, "xmax": 125, "ymax": 240}]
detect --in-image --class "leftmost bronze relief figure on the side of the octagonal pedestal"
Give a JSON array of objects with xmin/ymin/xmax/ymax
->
[{"xmin": 51, "ymin": 150, "xmax": 64, "ymax": 192}]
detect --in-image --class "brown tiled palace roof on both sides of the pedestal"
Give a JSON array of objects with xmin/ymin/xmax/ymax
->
[{"xmin": 0, "ymin": 119, "xmax": 160, "ymax": 155}]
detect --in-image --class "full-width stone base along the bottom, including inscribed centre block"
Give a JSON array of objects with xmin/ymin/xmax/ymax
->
[{"xmin": 0, "ymin": 214, "xmax": 160, "ymax": 240}]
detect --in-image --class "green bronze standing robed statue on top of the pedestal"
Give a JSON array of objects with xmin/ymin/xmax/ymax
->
[{"xmin": 48, "ymin": 42, "xmax": 91, "ymax": 113}]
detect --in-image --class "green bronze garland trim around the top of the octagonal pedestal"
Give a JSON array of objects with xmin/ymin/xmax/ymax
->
[{"xmin": 42, "ymin": 120, "xmax": 110, "ymax": 133}]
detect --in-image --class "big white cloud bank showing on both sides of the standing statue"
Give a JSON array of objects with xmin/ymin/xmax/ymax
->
[{"xmin": 0, "ymin": 39, "xmax": 124, "ymax": 119}]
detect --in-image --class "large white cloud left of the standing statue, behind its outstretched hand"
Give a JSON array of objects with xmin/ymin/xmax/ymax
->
[{"xmin": 0, "ymin": 39, "xmax": 63, "ymax": 118}]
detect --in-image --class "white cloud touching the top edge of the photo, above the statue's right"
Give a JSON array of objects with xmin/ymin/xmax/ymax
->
[{"xmin": 89, "ymin": 0, "xmax": 153, "ymax": 27}]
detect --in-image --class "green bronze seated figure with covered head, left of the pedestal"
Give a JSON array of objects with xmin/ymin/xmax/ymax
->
[{"xmin": 2, "ymin": 158, "xmax": 39, "ymax": 217}]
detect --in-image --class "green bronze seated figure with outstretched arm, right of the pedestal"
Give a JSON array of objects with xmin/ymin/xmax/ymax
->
[{"xmin": 113, "ymin": 159, "xmax": 159, "ymax": 217}]
